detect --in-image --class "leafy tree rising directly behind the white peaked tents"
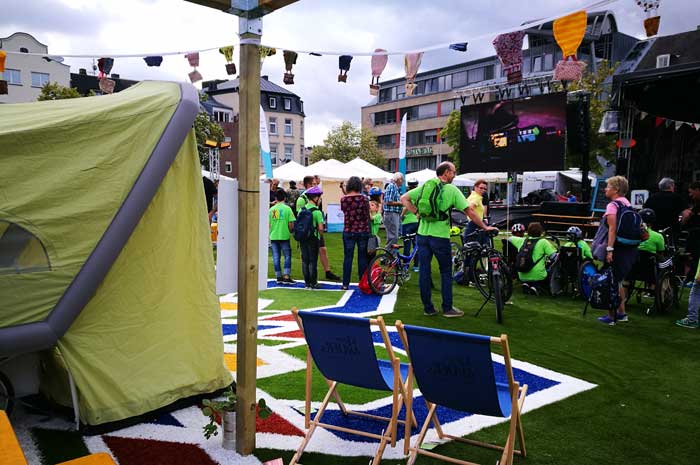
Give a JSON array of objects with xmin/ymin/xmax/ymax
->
[{"xmin": 310, "ymin": 121, "xmax": 386, "ymax": 168}]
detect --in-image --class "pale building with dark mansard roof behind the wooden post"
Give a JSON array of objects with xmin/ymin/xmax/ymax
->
[{"xmin": 203, "ymin": 76, "xmax": 305, "ymax": 169}]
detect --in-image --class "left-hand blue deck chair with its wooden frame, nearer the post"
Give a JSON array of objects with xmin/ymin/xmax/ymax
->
[{"xmin": 289, "ymin": 309, "xmax": 415, "ymax": 465}]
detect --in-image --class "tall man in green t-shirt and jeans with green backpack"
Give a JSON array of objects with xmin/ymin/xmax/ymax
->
[{"xmin": 401, "ymin": 161, "xmax": 496, "ymax": 318}]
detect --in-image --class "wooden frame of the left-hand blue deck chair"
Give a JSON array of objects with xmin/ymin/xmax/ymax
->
[{"xmin": 289, "ymin": 307, "xmax": 417, "ymax": 465}]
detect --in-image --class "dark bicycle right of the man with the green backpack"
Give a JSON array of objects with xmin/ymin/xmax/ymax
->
[{"xmin": 460, "ymin": 230, "xmax": 513, "ymax": 323}]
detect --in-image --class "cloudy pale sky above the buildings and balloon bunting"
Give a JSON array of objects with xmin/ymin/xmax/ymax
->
[{"xmin": 0, "ymin": 0, "xmax": 700, "ymax": 145}]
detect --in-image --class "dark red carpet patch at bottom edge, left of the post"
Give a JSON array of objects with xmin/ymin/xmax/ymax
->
[{"xmin": 102, "ymin": 436, "xmax": 217, "ymax": 465}]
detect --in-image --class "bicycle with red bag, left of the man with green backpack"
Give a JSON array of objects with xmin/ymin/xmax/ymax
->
[{"xmin": 367, "ymin": 234, "xmax": 418, "ymax": 295}]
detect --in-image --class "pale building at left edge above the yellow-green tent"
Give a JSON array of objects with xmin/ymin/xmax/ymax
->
[{"xmin": 0, "ymin": 32, "xmax": 70, "ymax": 103}]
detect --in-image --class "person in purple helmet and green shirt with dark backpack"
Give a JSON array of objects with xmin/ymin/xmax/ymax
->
[{"xmin": 294, "ymin": 186, "xmax": 323, "ymax": 289}]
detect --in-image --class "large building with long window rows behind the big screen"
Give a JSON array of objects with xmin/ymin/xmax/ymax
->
[{"xmin": 361, "ymin": 11, "xmax": 636, "ymax": 172}]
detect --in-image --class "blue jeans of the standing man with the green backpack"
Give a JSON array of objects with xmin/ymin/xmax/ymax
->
[{"xmin": 417, "ymin": 234, "xmax": 452, "ymax": 313}]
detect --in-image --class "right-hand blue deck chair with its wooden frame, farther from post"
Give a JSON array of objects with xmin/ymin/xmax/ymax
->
[{"xmin": 396, "ymin": 321, "xmax": 527, "ymax": 465}]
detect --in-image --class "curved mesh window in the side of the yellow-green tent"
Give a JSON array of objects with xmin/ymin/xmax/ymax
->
[{"xmin": 0, "ymin": 220, "xmax": 51, "ymax": 275}]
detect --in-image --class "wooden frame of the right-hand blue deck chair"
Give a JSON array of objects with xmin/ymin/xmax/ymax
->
[{"xmin": 396, "ymin": 320, "xmax": 528, "ymax": 465}]
